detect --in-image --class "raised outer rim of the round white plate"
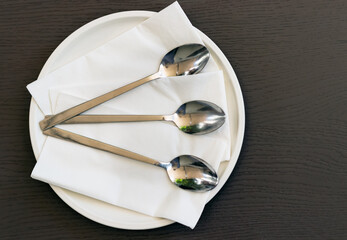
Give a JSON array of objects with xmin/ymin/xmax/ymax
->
[{"xmin": 29, "ymin": 10, "xmax": 245, "ymax": 230}]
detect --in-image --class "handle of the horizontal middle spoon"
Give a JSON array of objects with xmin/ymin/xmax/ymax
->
[{"xmin": 46, "ymin": 115, "xmax": 165, "ymax": 124}]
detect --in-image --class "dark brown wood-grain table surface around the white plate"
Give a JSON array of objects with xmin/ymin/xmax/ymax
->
[{"xmin": 0, "ymin": 0, "xmax": 347, "ymax": 239}]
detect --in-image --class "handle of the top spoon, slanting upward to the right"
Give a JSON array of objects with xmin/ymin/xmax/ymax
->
[{"xmin": 40, "ymin": 72, "xmax": 160, "ymax": 130}]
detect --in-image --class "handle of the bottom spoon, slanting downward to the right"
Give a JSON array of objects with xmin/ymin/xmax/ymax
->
[{"xmin": 43, "ymin": 127, "xmax": 162, "ymax": 166}]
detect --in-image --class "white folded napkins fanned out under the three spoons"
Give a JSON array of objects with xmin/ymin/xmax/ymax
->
[{"xmin": 28, "ymin": 2, "xmax": 230, "ymax": 228}]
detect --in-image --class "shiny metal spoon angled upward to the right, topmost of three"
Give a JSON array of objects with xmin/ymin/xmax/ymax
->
[{"xmin": 40, "ymin": 44, "xmax": 210, "ymax": 130}]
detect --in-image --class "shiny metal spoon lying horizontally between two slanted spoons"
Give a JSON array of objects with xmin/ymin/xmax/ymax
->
[{"xmin": 48, "ymin": 101, "xmax": 225, "ymax": 135}]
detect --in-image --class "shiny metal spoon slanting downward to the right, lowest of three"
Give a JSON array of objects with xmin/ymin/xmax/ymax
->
[{"xmin": 43, "ymin": 127, "xmax": 218, "ymax": 192}]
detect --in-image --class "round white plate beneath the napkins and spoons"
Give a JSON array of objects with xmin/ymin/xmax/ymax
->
[{"xmin": 29, "ymin": 11, "xmax": 245, "ymax": 229}]
